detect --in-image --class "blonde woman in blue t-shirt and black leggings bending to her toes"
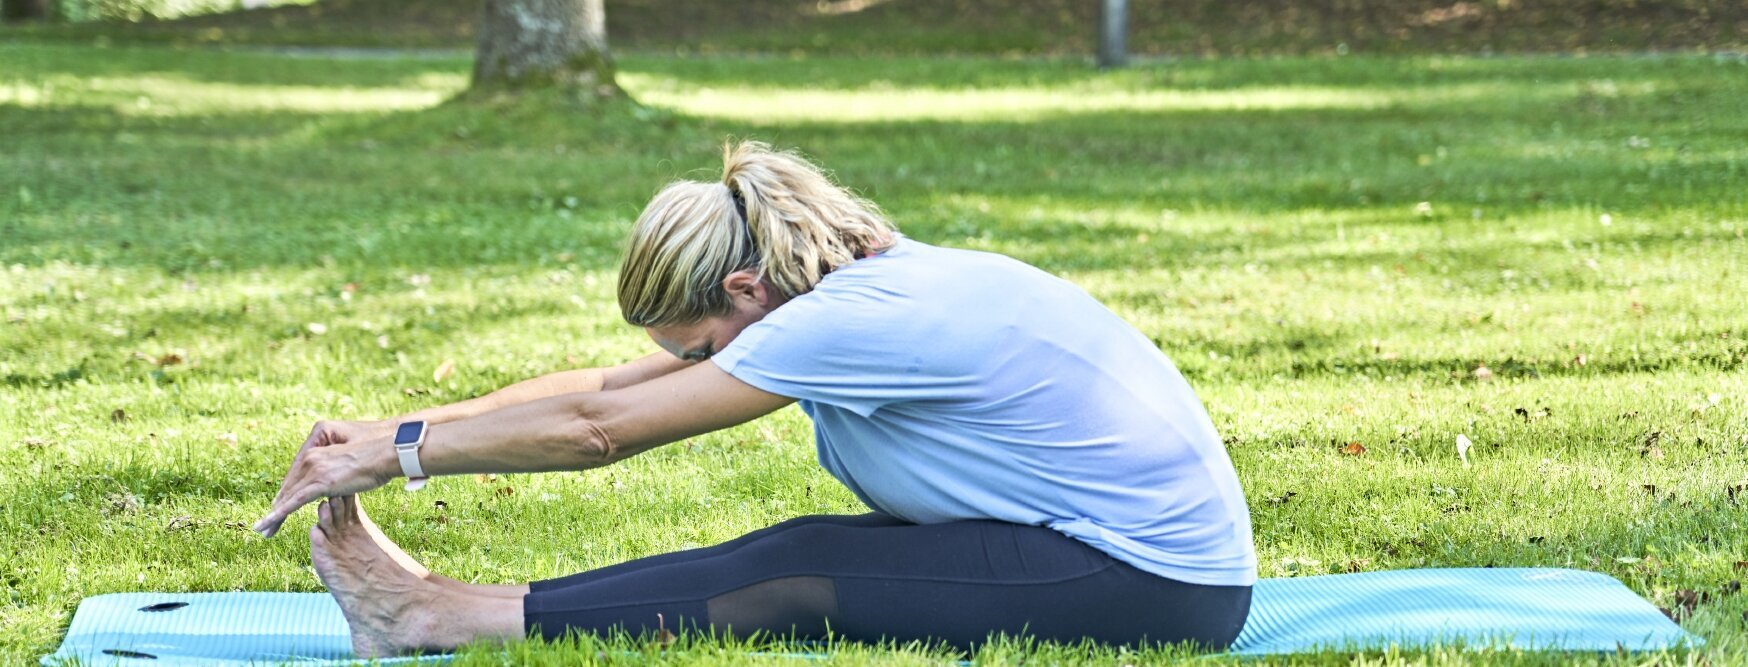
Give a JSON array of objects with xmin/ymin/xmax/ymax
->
[{"xmin": 255, "ymin": 143, "xmax": 1257, "ymax": 657}]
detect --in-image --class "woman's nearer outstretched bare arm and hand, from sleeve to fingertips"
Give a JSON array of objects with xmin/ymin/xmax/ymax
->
[{"xmin": 255, "ymin": 363, "xmax": 794, "ymax": 536}]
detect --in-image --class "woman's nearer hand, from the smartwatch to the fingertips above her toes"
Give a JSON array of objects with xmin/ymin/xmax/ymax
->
[{"xmin": 253, "ymin": 437, "xmax": 400, "ymax": 538}]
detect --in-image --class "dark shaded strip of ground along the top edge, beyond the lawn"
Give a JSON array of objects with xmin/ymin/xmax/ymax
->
[{"xmin": 0, "ymin": 0, "xmax": 1748, "ymax": 56}]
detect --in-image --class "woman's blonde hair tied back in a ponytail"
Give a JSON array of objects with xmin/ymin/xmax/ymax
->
[{"xmin": 619, "ymin": 141, "xmax": 897, "ymax": 327}]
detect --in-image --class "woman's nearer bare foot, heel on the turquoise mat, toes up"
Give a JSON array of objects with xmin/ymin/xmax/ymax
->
[{"xmin": 309, "ymin": 496, "xmax": 447, "ymax": 658}]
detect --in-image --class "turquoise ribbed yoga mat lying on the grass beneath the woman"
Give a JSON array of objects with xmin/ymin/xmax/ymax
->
[{"xmin": 42, "ymin": 567, "xmax": 1701, "ymax": 665}]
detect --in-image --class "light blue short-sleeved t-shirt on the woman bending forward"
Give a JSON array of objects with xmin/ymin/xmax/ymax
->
[{"xmin": 711, "ymin": 237, "xmax": 1257, "ymax": 585}]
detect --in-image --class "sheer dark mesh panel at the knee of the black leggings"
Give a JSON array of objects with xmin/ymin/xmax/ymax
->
[{"xmin": 706, "ymin": 576, "xmax": 837, "ymax": 639}]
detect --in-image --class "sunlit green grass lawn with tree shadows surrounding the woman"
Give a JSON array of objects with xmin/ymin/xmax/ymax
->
[{"xmin": 0, "ymin": 42, "xmax": 1748, "ymax": 665}]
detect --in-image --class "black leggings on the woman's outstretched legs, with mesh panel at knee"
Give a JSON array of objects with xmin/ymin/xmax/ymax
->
[{"xmin": 523, "ymin": 513, "xmax": 1250, "ymax": 650}]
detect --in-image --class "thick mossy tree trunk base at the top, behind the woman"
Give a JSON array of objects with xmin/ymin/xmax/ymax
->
[{"xmin": 474, "ymin": 0, "xmax": 621, "ymax": 98}]
